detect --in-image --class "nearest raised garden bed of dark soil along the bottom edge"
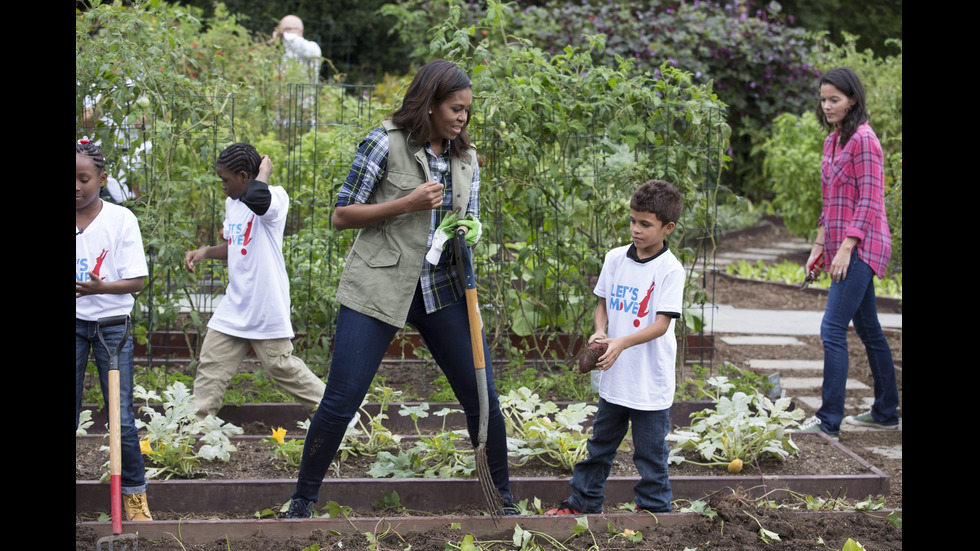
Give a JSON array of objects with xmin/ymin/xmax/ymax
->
[{"xmin": 75, "ymin": 509, "xmax": 902, "ymax": 551}]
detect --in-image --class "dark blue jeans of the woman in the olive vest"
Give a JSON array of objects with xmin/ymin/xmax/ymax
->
[{"xmin": 292, "ymin": 288, "xmax": 512, "ymax": 503}]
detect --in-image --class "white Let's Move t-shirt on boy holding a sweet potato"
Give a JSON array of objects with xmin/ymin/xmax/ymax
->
[{"xmin": 594, "ymin": 243, "xmax": 685, "ymax": 411}]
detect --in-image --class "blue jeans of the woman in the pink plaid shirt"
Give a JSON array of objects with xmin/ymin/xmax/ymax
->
[{"xmin": 817, "ymin": 254, "xmax": 898, "ymax": 434}]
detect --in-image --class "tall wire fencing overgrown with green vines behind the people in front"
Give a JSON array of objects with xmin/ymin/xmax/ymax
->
[{"xmin": 76, "ymin": 84, "xmax": 725, "ymax": 375}]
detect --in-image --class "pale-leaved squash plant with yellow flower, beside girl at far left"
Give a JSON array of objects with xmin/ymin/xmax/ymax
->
[{"xmin": 133, "ymin": 382, "xmax": 244, "ymax": 479}]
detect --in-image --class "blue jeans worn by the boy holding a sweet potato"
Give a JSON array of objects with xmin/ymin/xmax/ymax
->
[{"xmin": 568, "ymin": 398, "xmax": 674, "ymax": 513}]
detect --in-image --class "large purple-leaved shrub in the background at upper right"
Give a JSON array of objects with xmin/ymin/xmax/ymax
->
[{"xmin": 518, "ymin": 0, "xmax": 819, "ymax": 196}]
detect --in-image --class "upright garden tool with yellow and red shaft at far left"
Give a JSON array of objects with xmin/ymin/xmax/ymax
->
[{"xmin": 97, "ymin": 315, "xmax": 138, "ymax": 551}]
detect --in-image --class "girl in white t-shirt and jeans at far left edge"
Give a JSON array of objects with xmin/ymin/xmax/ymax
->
[{"xmin": 75, "ymin": 139, "xmax": 153, "ymax": 520}]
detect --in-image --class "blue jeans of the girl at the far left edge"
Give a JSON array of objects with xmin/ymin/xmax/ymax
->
[{"xmin": 75, "ymin": 318, "xmax": 146, "ymax": 495}]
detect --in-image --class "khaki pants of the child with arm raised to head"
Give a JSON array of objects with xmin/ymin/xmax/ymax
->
[{"xmin": 194, "ymin": 329, "xmax": 325, "ymax": 419}]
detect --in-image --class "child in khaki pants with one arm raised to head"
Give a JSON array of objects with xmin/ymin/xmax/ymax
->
[{"xmin": 184, "ymin": 143, "xmax": 325, "ymax": 419}]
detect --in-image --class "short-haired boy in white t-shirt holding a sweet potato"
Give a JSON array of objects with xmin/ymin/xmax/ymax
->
[{"xmin": 546, "ymin": 180, "xmax": 685, "ymax": 515}]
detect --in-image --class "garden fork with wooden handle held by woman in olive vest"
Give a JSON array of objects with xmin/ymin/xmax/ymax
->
[{"xmin": 455, "ymin": 228, "xmax": 503, "ymax": 526}]
